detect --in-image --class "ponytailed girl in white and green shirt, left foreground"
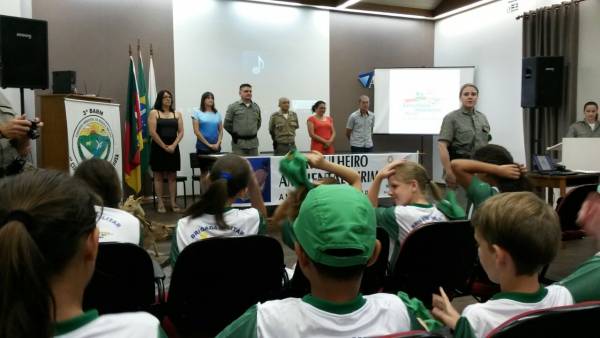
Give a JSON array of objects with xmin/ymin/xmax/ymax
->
[{"xmin": 0, "ymin": 170, "xmax": 165, "ymax": 338}]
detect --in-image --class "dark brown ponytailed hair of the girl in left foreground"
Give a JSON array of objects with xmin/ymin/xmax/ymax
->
[{"xmin": 0, "ymin": 170, "xmax": 97, "ymax": 337}]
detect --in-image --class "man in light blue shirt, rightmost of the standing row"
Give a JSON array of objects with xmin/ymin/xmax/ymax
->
[{"xmin": 346, "ymin": 95, "xmax": 375, "ymax": 153}]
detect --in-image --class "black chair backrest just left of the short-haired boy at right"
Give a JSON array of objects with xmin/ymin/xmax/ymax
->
[{"xmin": 386, "ymin": 221, "xmax": 477, "ymax": 307}]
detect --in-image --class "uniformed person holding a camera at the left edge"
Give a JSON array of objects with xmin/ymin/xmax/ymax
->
[{"xmin": 0, "ymin": 92, "xmax": 41, "ymax": 178}]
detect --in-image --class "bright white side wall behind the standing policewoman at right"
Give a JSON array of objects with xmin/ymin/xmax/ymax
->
[{"xmin": 434, "ymin": 0, "xmax": 600, "ymax": 176}]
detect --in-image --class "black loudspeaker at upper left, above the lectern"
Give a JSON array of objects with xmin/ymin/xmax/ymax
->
[{"xmin": 0, "ymin": 15, "xmax": 48, "ymax": 89}]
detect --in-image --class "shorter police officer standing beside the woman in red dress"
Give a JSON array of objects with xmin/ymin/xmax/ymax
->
[{"xmin": 269, "ymin": 97, "xmax": 299, "ymax": 156}]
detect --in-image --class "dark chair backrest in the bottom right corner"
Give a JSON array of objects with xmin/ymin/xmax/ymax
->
[{"xmin": 487, "ymin": 301, "xmax": 600, "ymax": 338}]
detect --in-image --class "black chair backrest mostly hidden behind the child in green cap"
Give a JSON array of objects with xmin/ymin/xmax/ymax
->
[{"xmin": 282, "ymin": 228, "xmax": 390, "ymax": 298}]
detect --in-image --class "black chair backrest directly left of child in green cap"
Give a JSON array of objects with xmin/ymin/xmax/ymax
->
[{"xmin": 167, "ymin": 235, "xmax": 285, "ymax": 337}]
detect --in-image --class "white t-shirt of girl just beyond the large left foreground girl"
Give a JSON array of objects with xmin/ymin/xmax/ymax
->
[{"xmin": 96, "ymin": 206, "xmax": 141, "ymax": 245}]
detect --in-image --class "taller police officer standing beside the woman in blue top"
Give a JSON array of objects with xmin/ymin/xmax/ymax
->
[{"xmin": 223, "ymin": 83, "xmax": 261, "ymax": 156}]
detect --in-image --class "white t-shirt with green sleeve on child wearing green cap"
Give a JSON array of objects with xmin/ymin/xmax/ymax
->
[{"xmin": 217, "ymin": 293, "xmax": 413, "ymax": 338}]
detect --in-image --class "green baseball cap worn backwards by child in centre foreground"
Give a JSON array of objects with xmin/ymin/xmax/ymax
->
[{"xmin": 293, "ymin": 184, "xmax": 377, "ymax": 267}]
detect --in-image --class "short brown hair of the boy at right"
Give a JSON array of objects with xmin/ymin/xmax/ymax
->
[{"xmin": 471, "ymin": 192, "xmax": 561, "ymax": 275}]
